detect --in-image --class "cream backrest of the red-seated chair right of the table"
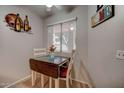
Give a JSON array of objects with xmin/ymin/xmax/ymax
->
[{"xmin": 66, "ymin": 50, "xmax": 75, "ymax": 78}]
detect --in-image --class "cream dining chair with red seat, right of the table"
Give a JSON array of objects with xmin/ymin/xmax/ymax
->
[{"xmin": 49, "ymin": 50, "xmax": 75, "ymax": 88}]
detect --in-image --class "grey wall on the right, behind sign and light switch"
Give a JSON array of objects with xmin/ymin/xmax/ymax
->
[{"xmin": 87, "ymin": 6, "xmax": 124, "ymax": 87}]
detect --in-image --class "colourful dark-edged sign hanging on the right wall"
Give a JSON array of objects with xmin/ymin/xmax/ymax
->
[{"xmin": 91, "ymin": 5, "xmax": 115, "ymax": 28}]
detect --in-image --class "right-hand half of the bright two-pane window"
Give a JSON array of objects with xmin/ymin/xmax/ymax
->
[{"xmin": 62, "ymin": 21, "xmax": 76, "ymax": 52}]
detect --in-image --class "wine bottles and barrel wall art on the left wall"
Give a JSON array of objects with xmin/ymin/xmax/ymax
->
[{"xmin": 4, "ymin": 13, "xmax": 31, "ymax": 33}]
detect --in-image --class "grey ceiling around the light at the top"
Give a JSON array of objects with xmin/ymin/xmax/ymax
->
[{"xmin": 25, "ymin": 5, "xmax": 76, "ymax": 18}]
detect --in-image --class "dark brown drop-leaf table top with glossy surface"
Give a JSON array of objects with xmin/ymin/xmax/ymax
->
[{"xmin": 29, "ymin": 55, "xmax": 69, "ymax": 78}]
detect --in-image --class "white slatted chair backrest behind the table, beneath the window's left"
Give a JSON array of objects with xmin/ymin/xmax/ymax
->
[{"xmin": 33, "ymin": 48, "xmax": 48, "ymax": 57}]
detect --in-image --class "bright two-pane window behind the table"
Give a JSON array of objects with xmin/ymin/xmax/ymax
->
[{"xmin": 48, "ymin": 21, "xmax": 76, "ymax": 52}]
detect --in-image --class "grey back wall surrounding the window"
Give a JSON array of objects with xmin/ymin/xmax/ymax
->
[{"xmin": 44, "ymin": 6, "xmax": 93, "ymax": 84}]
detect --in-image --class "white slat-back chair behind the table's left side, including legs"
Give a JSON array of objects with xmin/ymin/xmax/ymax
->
[{"xmin": 31, "ymin": 48, "xmax": 48, "ymax": 87}]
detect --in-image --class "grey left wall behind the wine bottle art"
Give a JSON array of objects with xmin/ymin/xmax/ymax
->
[{"xmin": 0, "ymin": 6, "xmax": 43, "ymax": 85}]
